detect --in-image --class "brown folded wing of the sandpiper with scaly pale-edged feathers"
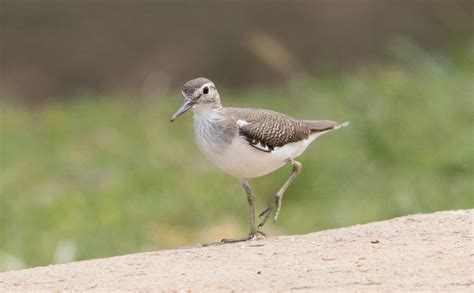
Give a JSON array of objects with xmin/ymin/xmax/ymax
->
[{"xmin": 229, "ymin": 108, "xmax": 311, "ymax": 152}]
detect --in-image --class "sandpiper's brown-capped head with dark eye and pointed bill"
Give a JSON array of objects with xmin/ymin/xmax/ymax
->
[{"xmin": 170, "ymin": 77, "xmax": 221, "ymax": 122}]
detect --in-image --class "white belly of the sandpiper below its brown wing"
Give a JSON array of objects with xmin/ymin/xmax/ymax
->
[{"xmin": 196, "ymin": 133, "xmax": 313, "ymax": 178}]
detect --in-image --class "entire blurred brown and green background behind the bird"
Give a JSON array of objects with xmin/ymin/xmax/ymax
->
[{"xmin": 0, "ymin": 0, "xmax": 474, "ymax": 270}]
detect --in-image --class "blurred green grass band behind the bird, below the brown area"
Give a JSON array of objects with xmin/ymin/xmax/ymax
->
[{"xmin": 0, "ymin": 43, "xmax": 474, "ymax": 270}]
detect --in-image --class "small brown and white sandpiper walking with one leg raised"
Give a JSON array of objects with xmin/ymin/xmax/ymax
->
[{"xmin": 171, "ymin": 77, "xmax": 348, "ymax": 242}]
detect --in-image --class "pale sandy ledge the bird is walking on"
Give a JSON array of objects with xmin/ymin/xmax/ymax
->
[{"xmin": 0, "ymin": 210, "xmax": 474, "ymax": 292}]
